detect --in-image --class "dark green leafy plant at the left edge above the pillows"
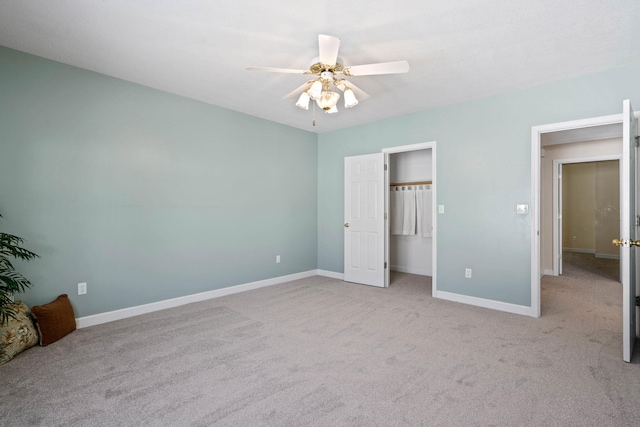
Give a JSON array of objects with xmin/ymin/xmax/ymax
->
[{"xmin": 0, "ymin": 215, "xmax": 39, "ymax": 325}]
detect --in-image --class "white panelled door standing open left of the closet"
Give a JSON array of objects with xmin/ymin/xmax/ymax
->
[{"xmin": 344, "ymin": 153, "xmax": 385, "ymax": 287}]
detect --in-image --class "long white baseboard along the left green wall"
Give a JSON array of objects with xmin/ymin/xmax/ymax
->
[{"xmin": 76, "ymin": 270, "xmax": 321, "ymax": 328}]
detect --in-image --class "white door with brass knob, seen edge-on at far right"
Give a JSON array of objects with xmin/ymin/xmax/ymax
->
[{"xmin": 614, "ymin": 100, "xmax": 640, "ymax": 362}]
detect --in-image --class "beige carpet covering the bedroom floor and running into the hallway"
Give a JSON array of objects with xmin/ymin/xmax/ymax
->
[{"xmin": 0, "ymin": 266, "xmax": 640, "ymax": 426}]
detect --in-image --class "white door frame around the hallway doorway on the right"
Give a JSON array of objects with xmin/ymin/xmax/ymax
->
[{"xmin": 531, "ymin": 114, "xmax": 622, "ymax": 317}]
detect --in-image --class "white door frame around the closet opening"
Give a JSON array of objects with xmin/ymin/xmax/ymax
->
[{"xmin": 382, "ymin": 141, "xmax": 438, "ymax": 297}]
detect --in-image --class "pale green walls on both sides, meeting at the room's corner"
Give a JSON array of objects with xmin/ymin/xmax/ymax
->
[{"xmin": 0, "ymin": 44, "xmax": 640, "ymax": 316}]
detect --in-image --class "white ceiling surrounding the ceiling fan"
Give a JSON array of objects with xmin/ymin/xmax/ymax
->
[{"xmin": 0, "ymin": 0, "xmax": 640, "ymax": 132}]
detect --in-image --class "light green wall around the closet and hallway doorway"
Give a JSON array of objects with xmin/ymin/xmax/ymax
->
[{"xmin": 318, "ymin": 63, "xmax": 640, "ymax": 306}]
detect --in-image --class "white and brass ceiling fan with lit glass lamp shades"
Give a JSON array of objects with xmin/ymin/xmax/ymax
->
[{"xmin": 247, "ymin": 34, "xmax": 409, "ymax": 118}]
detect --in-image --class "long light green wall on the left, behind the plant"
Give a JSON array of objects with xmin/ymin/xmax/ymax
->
[{"xmin": 0, "ymin": 47, "xmax": 318, "ymax": 317}]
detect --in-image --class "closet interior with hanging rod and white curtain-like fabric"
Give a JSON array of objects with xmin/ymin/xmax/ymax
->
[{"xmin": 389, "ymin": 149, "xmax": 434, "ymax": 283}]
